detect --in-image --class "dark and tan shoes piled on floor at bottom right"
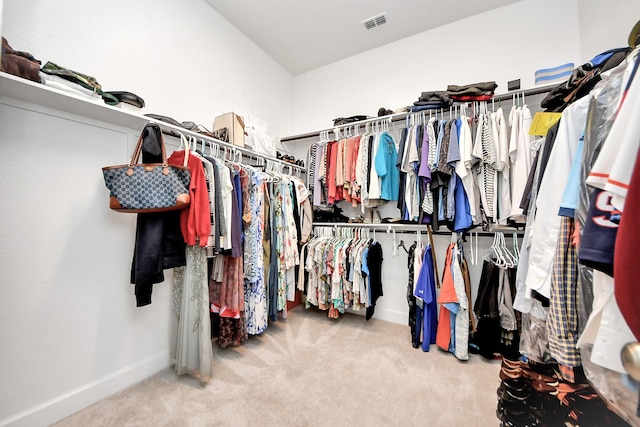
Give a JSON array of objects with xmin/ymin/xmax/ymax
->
[{"xmin": 496, "ymin": 359, "xmax": 626, "ymax": 427}]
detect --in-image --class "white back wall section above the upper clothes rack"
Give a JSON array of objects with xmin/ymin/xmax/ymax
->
[{"xmin": 293, "ymin": 0, "xmax": 580, "ymax": 134}]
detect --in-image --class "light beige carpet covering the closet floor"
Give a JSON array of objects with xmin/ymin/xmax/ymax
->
[{"xmin": 55, "ymin": 307, "xmax": 500, "ymax": 427}]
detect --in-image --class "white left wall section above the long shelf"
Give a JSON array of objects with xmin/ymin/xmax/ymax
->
[{"xmin": 2, "ymin": 0, "xmax": 293, "ymax": 137}]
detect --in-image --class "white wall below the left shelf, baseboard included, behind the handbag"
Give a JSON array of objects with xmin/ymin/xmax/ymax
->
[{"xmin": 0, "ymin": 98, "xmax": 172, "ymax": 425}]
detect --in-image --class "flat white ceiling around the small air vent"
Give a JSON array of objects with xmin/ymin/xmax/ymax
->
[{"xmin": 206, "ymin": 0, "xmax": 520, "ymax": 75}]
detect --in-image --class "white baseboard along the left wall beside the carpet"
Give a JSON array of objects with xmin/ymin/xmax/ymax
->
[{"xmin": 0, "ymin": 352, "xmax": 169, "ymax": 427}]
